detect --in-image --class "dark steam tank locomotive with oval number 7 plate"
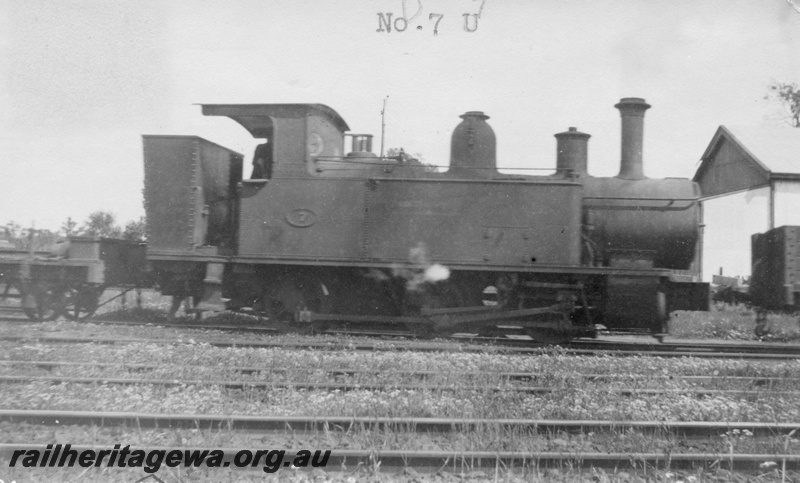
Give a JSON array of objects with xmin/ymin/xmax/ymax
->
[{"xmin": 144, "ymin": 98, "xmax": 708, "ymax": 341}]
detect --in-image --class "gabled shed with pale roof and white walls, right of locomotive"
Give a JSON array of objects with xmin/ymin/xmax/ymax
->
[{"xmin": 694, "ymin": 126, "xmax": 800, "ymax": 280}]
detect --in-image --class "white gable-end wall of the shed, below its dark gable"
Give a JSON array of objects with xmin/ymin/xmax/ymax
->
[{"xmin": 702, "ymin": 187, "xmax": 772, "ymax": 282}]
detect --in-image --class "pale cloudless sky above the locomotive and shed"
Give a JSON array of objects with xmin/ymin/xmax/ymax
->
[{"xmin": 0, "ymin": 0, "xmax": 800, "ymax": 230}]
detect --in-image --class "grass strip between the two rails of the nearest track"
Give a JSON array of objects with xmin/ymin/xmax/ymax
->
[{"xmin": 0, "ymin": 422, "xmax": 800, "ymax": 462}]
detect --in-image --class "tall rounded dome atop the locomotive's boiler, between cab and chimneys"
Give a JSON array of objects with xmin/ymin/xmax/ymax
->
[{"xmin": 449, "ymin": 111, "xmax": 497, "ymax": 178}]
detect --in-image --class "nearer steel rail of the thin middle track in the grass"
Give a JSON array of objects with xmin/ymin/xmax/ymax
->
[{"xmin": 6, "ymin": 375, "xmax": 800, "ymax": 397}]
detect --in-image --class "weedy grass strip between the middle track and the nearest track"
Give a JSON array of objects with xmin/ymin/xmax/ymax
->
[{"xmin": 3, "ymin": 381, "xmax": 800, "ymax": 422}]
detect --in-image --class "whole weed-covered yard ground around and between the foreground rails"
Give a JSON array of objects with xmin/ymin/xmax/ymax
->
[{"xmin": 0, "ymin": 321, "xmax": 800, "ymax": 483}]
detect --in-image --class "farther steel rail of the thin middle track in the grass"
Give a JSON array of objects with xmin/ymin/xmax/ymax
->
[{"xmin": 0, "ymin": 360, "xmax": 800, "ymax": 387}]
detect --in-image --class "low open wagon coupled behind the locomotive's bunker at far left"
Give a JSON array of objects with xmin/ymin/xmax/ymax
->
[{"xmin": 0, "ymin": 237, "xmax": 147, "ymax": 321}]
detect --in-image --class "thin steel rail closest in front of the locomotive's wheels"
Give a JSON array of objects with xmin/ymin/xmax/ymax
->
[{"xmin": 0, "ymin": 335, "xmax": 800, "ymax": 360}]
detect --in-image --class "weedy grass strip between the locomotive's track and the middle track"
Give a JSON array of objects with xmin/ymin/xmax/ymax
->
[{"xmin": 0, "ymin": 340, "xmax": 800, "ymax": 387}]
